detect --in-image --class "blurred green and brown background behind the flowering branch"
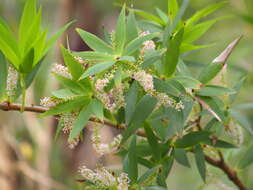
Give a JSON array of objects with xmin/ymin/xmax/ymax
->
[{"xmin": 0, "ymin": 0, "xmax": 253, "ymax": 190}]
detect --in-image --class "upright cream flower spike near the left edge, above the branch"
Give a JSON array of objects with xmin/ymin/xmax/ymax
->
[{"xmin": 6, "ymin": 65, "xmax": 18, "ymax": 96}]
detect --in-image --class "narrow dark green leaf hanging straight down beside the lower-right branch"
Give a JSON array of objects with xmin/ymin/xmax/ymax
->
[{"xmin": 194, "ymin": 144, "xmax": 206, "ymax": 182}]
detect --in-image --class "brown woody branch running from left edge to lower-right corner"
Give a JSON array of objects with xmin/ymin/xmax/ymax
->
[{"xmin": 0, "ymin": 103, "xmax": 248, "ymax": 190}]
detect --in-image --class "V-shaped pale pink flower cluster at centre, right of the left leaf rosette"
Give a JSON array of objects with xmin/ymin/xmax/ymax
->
[{"xmin": 95, "ymin": 77, "xmax": 125, "ymax": 112}]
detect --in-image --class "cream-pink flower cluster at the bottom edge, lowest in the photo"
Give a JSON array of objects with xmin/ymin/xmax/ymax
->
[{"xmin": 79, "ymin": 166, "xmax": 130, "ymax": 190}]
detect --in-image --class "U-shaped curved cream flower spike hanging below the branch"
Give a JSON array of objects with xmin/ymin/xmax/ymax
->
[{"xmin": 92, "ymin": 126, "xmax": 122, "ymax": 155}]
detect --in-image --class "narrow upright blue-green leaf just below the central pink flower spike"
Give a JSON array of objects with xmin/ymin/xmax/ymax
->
[{"xmin": 125, "ymin": 81, "xmax": 138, "ymax": 125}]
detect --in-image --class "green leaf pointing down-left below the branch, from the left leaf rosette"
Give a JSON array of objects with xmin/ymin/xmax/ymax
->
[{"xmin": 68, "ymin": 102, "xmax": 92, "ymax": 141}]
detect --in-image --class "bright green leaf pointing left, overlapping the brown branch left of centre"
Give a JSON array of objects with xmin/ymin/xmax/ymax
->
[{"xmin": 41, "ymin": 96, "xmax": 89, "ymax": 116}]
